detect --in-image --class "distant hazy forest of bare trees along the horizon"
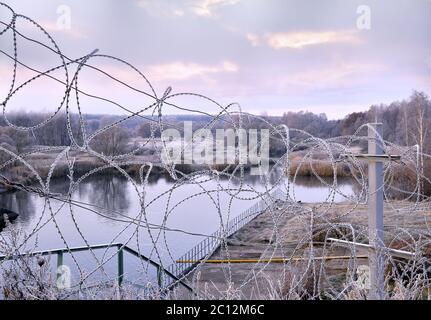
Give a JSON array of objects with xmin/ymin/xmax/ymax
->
[{"xmin": 0, "ymin": 91, "xmax": 431, "ymax": 154}]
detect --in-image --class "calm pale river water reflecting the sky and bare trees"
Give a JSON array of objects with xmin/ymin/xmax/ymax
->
[{"xmin": 0, "ymin": 175, "xmax": 354, "ymax": 288}]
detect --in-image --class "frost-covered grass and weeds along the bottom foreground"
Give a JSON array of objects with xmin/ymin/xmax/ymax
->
[{"xmin": 0, "ymin": 210, "xmax": 431, "ymax": 300}]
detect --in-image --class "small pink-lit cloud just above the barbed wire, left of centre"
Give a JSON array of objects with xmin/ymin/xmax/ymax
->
[{"xmin": 147, "ymin": 61, "xmax": 239, "ymax": 81}]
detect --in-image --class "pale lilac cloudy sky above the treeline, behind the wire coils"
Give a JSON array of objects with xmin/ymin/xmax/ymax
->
[{"xmin": 0, "ymin": 0, "xmax": 431, "ymax": 119}]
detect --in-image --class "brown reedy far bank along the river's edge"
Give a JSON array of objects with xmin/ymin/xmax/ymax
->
[{"xmin": 0, "ymin": 151, "xmax": 424, "ymax": 198}]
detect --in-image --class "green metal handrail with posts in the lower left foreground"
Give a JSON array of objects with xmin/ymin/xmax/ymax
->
[{"xmin": 0, "ymin": 243, "xmax": 193, "ymax": 292}]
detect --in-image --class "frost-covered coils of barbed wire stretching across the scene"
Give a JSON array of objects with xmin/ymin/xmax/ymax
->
[{"xmin": 0, "ymin": 2, "xmax": 431, "ymax": 299}]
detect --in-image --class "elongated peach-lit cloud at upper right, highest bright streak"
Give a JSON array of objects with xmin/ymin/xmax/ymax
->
[{"xmin": 266, "ymin": 31, "xmax": 360, "ymax": 49}]
